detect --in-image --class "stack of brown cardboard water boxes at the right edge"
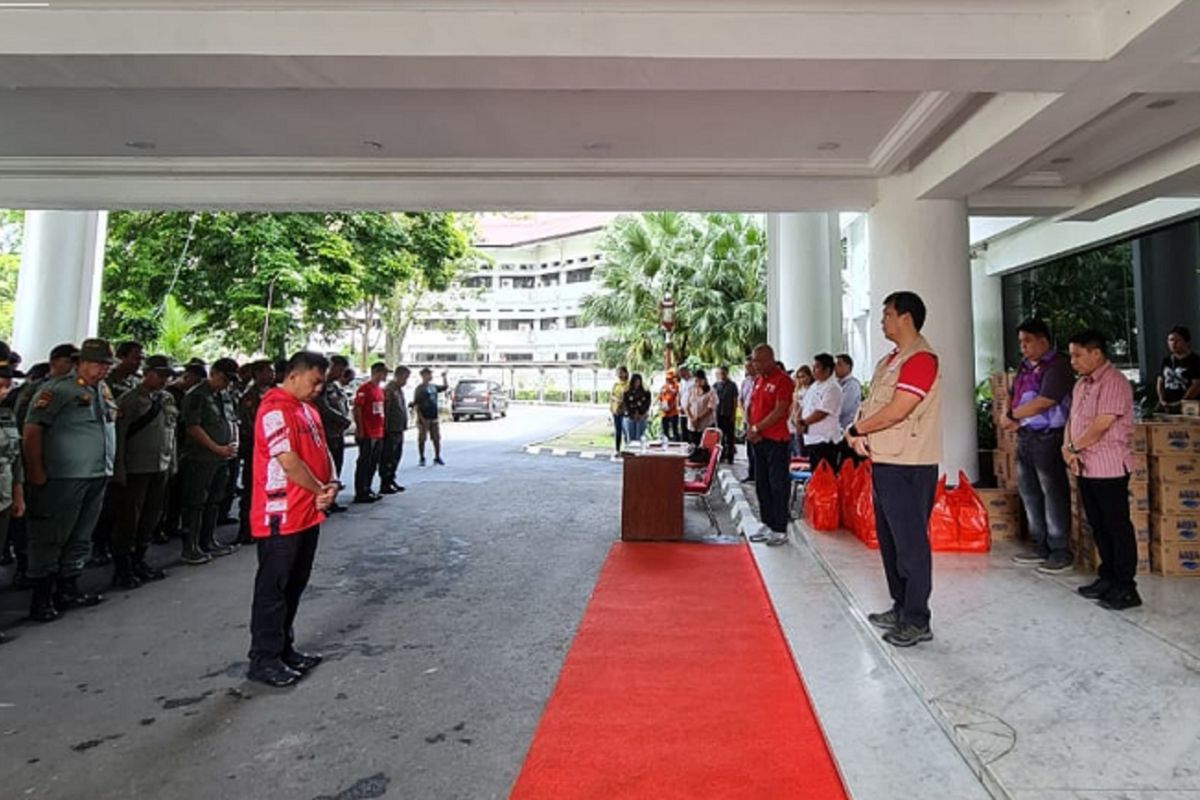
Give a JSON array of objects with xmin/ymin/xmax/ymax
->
[{"xmin": 1145, "ymin": 416, "xmax": 1200, "ymax": 576}]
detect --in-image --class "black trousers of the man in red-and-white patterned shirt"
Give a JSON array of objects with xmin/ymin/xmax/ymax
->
[{"xmin": 250, "ymin": 525, "xmax": 320, "ymax": 663}]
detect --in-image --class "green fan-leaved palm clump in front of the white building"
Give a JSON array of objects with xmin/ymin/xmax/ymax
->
[{"xmin": 582, "ymin": 211, "xmax": 767, "ymax": 371}]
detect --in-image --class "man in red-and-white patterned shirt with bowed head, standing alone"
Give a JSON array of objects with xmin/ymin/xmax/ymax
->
[{"xmin": 247, "ymin": 351, "xmax": 337, "ymax": 686}]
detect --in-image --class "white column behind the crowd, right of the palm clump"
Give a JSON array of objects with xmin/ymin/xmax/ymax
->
[{"xmin": 767, "ymin": 213, "xmax": 844, "ymax": 369}]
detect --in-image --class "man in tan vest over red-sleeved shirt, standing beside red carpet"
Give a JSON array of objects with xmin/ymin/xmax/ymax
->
[{"xmin": 846, "ymin": 291, "xmax": 942, "ymax": 648}]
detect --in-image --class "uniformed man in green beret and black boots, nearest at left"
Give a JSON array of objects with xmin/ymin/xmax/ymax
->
[{"xmin": 23, "ymin": 339, "xmax": 116, "ymax": 622}]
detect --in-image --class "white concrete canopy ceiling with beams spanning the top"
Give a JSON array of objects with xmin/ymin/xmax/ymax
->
[{"xmin": 0, "ymin": 0, "xmax": 1200, "ymax": 219}]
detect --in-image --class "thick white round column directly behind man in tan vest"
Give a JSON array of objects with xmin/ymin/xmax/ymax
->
[{"xmin": 868, "ymin": 176, "xmax": 979, "ymax": 482}]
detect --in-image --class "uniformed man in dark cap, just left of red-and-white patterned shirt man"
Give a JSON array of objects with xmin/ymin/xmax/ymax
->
[{"xmin": 180, "ymin": 359, "xmax": 238, "ymax": 565}]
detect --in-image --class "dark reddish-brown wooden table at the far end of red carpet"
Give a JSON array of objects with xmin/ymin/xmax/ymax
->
[{"xmin": 620, "ymin": 447, "xmax": 688, "ymax": 542}]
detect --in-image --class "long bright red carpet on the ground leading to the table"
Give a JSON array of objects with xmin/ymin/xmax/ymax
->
[{"xmin": 511, "ymin": 543, "xmax": 846, "ymax": 800}]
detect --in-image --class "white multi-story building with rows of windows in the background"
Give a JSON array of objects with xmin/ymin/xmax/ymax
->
[{"xmin": 401, "ymin": 213, "xmax": 617, "ymax": 367}]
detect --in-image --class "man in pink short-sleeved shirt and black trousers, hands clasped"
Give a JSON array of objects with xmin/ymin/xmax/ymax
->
[{"xmin": 1062, "ymin": 331, "xmax": 1141, "ymax": 610}]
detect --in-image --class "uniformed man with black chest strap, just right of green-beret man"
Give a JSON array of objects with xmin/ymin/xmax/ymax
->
[{"xmin": 113, "ymin": 355, "xmax": 179, "ymax": 589}]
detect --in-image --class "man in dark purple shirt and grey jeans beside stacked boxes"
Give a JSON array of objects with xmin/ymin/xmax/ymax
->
[{"xmin": 1002, "ymin": 319, "xmax": 1075, "ymax": 573}]
